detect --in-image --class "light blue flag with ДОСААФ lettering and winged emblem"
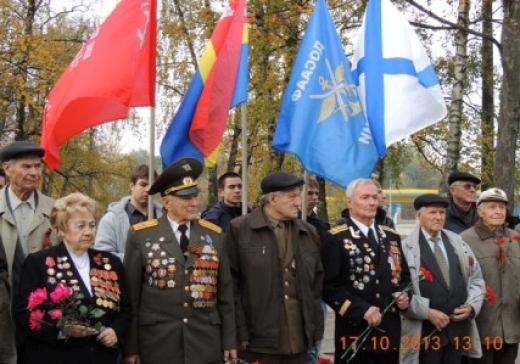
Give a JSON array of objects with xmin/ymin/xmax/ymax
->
[{"xmin": 273, "ymin": 0, "xmax": 378, "ymax": 187}]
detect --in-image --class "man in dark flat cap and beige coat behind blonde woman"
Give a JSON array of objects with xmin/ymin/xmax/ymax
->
[{"xmin": 0, "ymin": 140, "xmax": 56, "ymax": 362}]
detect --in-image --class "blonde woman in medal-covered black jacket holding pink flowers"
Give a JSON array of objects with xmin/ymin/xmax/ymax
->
[{"xmin": 15, "ymin": 192, "xmax": 131, "ymax": 364}]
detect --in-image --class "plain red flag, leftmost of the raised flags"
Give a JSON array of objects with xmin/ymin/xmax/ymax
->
[{"xmin": 41, "ymin": 0, "xmax": 157, "ymax": 170}]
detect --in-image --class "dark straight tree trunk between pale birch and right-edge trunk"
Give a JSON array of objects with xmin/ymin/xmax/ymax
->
[{"xmin": 480, "ymin": 1, "xmax": 495, "ymax": 190}]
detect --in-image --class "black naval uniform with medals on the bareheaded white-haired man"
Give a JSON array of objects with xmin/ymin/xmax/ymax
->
[{"xmin": 321, "ymin": 218, "xmax": 410, "ymax": 363}]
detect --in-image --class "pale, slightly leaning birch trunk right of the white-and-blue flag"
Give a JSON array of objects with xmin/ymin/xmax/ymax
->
[{"xmin": 439, "ymin": 0, "xmax": 470, "ymax": 193}]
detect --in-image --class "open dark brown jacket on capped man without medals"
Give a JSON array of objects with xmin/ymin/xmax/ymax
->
[{"xmin": 225, "ymin": 207, "xmax": 323, "ymax": 349}]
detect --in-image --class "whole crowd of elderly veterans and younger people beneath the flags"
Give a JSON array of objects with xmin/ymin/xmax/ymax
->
[{"xmin": 0, "ymin": 141, "xmax": 520, "ymax": 364}]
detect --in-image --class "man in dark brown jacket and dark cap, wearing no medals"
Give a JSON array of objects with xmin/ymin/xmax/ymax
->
[{"xmin": 226, "ymin": 172, "xmax": 323, "ymax": 364}]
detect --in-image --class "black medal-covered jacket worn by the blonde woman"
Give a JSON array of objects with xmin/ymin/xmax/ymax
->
[{"xmin": 15, "ymin": 243, "xmax": 131, "ymax": 364}]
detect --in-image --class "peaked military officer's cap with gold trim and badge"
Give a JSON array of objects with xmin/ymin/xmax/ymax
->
[{"xmin": 149, "ymin": 157, "xmax": 204, "ymax": 196}]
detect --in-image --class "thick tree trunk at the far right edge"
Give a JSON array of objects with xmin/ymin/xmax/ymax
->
[{"xmin": 493, "ymin": 0, "xmax": 520, "ymax": 209}]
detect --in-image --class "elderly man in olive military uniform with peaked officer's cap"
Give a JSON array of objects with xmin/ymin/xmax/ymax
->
[{"xmin": 124, "ymin": 158, "xmax": 236, "ymax": 364}]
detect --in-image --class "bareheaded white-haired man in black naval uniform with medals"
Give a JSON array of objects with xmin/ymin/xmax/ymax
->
[{"xmin": 321, "ymin": 179, "xmax": 410, "ymax": 364}]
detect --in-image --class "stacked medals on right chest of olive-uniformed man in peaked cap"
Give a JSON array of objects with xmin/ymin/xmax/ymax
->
[{"xmin": 190, "ymin": 244, "xmax": 219, "ymax": 308}]
